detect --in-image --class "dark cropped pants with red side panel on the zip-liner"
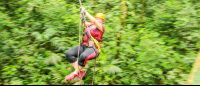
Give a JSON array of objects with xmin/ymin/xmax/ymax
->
[{"xmin": 65, "ymin": 45, "xmax": 99, "ymax": 67}]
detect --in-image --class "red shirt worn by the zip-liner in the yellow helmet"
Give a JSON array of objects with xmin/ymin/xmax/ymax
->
[{"xmin": 82, "ymin": 23, "xmax": 105, "ymax": 47}]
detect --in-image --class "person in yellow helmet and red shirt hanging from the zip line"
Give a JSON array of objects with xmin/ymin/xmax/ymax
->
[{"xmin": 65, "ymin": 7, "xmax": 105, "ymax": 82}]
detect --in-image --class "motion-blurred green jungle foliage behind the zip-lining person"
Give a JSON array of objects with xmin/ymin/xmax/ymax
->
[{"xmin": 0, "ymin": 0, "xmax": 200, "ymax": 85}]
